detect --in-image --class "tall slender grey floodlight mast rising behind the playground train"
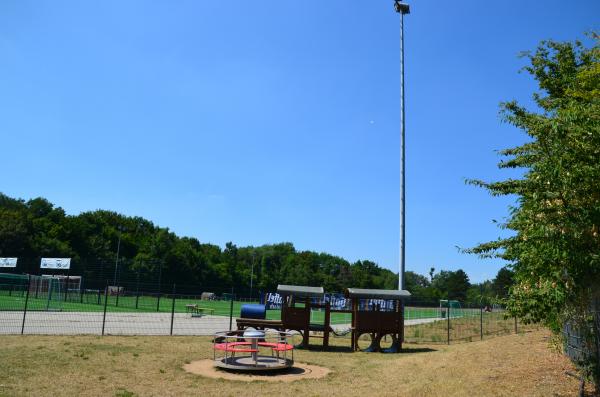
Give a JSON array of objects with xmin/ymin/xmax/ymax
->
[{"xmin": 394, "ymin": 0, "xmax": 410, "ymax": 290}]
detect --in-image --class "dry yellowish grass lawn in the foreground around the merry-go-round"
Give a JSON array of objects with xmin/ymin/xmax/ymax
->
[{"xmin": 0, "ymin": 330, "xmax": 592, "ymax": 397}]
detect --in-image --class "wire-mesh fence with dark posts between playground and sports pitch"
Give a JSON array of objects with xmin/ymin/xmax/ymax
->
[{"xmin": 0, "ymin": 273, "xmax": 536, "ymax": 343}]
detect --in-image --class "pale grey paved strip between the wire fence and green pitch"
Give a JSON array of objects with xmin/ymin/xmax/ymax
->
[{"xmin": 0, "ymin": 311, "xmax": 439, "ymax": 335}]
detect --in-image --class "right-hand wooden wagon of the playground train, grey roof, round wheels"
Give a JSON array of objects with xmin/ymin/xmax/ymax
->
[{"xmin": 346, "ymin": 288, "xmax": 410, "ymax": 353}]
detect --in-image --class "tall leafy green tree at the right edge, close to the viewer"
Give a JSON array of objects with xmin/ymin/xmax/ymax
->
[{"xmin": 471, "ymin": 36, "xmax": 600, "ymax": 385}]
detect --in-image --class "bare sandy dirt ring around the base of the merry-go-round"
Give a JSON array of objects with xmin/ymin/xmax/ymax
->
[{"xmin": 183, "ymin": 360, "xmax": 331, "ymax": 382}]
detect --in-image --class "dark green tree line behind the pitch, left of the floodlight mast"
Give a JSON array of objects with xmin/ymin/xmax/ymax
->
[{"xmin": 0, "ymin": 193, "xmax": 398, "ymax": 294}]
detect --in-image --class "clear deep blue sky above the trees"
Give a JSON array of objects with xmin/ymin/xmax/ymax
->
[{"xmin": 0, "ymin": 0, "xmax": 600, "ymax": 281}]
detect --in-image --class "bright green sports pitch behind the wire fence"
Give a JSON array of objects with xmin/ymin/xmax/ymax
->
[{"xmin": 0, "ymin": 290, "xmax": 439, "ymax": 324}]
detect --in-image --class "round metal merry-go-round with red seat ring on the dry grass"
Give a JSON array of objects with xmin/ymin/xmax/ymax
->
[{"xmin": 213, "ymin": 328, "xmax": 294, "ymax": 372}]
